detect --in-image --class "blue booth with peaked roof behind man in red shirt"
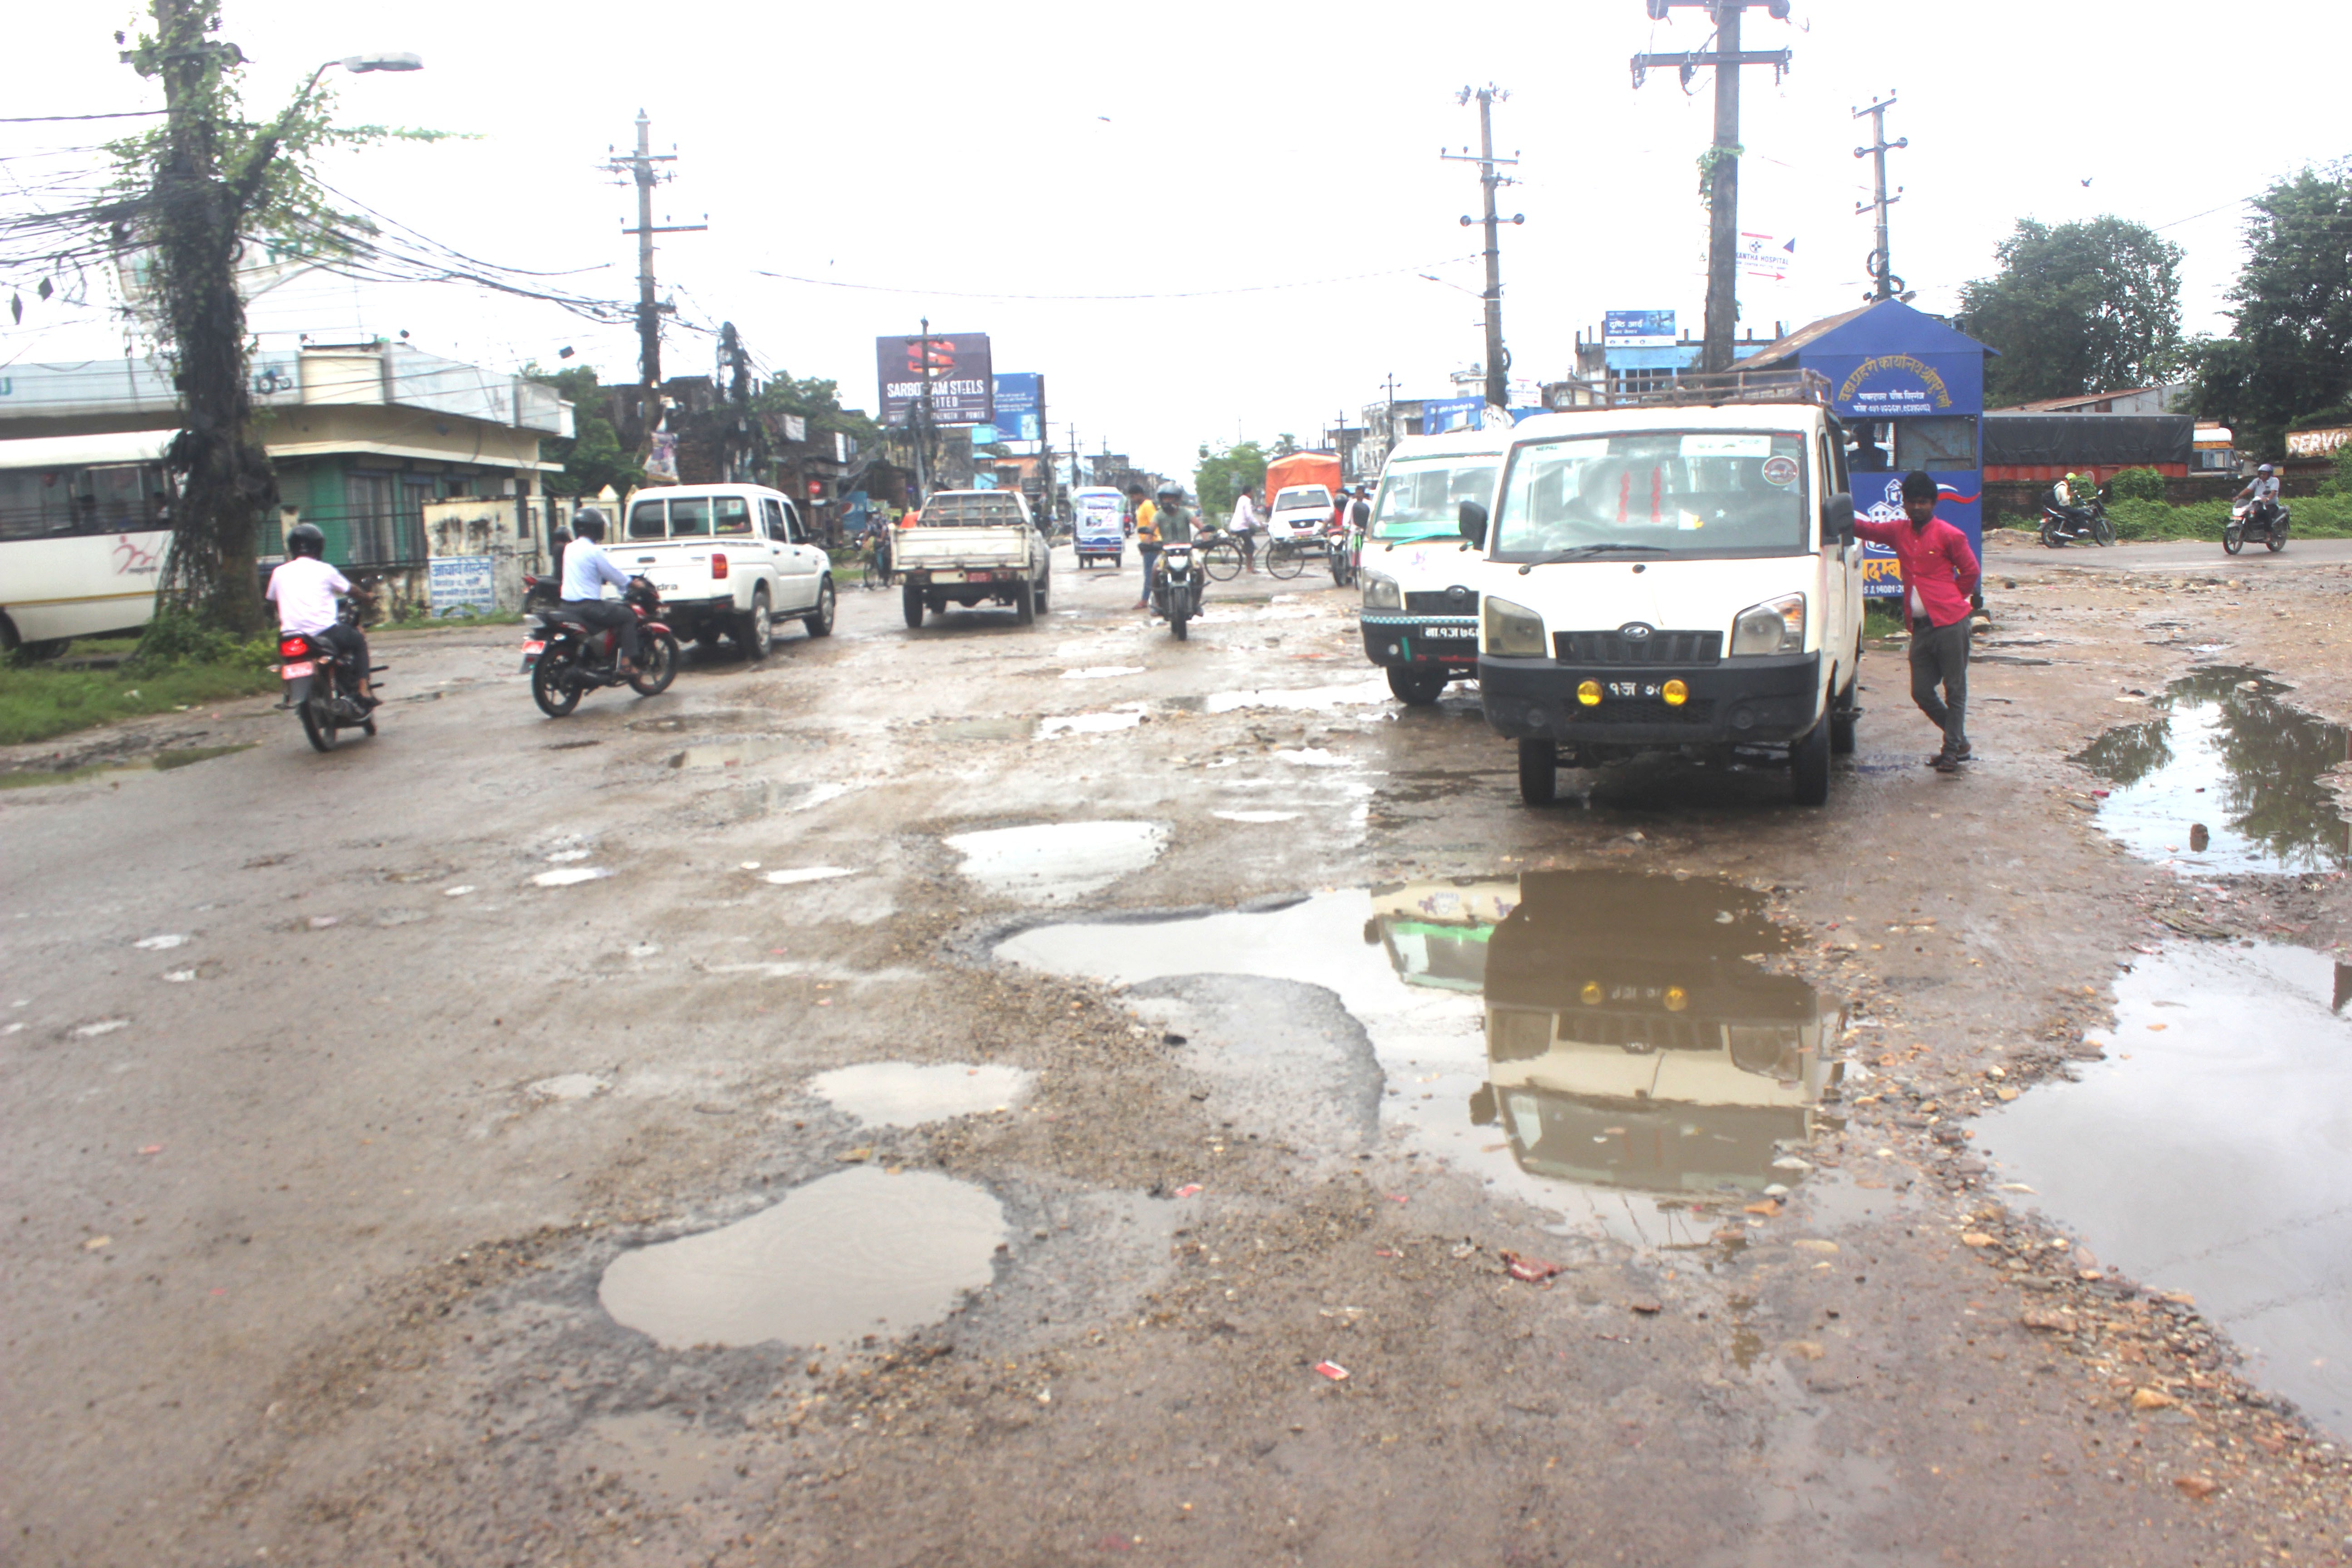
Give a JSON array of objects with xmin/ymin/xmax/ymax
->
[{"xmin": 1740, "ymin": 299, "xmax": 1999, "ymax": 597}]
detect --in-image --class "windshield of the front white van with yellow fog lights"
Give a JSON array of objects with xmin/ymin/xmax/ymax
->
[{"xmin": 1494, "ymin": 430, "xmax": 1813, "ymax": 562}]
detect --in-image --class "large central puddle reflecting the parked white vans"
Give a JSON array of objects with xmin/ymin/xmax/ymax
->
[{"xmin": 997, "ymin": 870, "xmax": 1842, "ymax": 1244}]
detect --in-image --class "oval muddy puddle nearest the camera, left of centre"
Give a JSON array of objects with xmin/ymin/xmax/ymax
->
[{"xmin": 598, "ymin": 1166, "xmax": 1007, "ymax": 1349}]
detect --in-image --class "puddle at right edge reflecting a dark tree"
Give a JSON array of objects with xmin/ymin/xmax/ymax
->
[{"xmin": 2074, "ymin": 665, "xmax": 2352, "ymax": 872}]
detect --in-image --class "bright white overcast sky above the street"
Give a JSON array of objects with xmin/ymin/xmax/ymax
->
[{"xmin": 0, "ymin": 0, "xmax": 2352, "ymax": 472}]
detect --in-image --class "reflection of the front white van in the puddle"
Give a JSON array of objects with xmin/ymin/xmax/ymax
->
[{"xmin": 1472, "ymin": 872, "xmax": 1842, "ymax": 1192}]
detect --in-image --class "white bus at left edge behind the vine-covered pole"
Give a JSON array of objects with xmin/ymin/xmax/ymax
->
[{"xmin": 0, "ymin": 430, "xmax": 176, "ymax": 658}]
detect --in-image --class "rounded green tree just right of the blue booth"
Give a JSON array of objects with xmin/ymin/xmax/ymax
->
[{"xmin": 1961, "ymin": 216, "xmax": 2183, "ymax": 407}]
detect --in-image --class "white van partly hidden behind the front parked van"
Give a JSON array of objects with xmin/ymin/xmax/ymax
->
[{"xmin": 1357, "ymin": 430, "xmax": 1512, "ymax": 708}]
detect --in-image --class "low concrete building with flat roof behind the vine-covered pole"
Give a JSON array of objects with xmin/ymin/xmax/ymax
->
[{"xmin": 0, "ymin": 338, "xmax": 572, "ymax": 573}]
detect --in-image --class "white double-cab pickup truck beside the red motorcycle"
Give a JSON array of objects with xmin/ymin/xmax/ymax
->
[{"xmin": 607, "ymin": 484, "xmax": 835, "ymax": 658}]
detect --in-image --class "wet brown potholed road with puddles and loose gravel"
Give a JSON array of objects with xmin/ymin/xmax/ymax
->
[{"xmin": 0, "ymin": 534, "xmax": 2352, "ymax": 1563}]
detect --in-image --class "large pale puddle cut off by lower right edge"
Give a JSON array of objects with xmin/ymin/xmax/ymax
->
[{"xmin": 1978, "ymin": 943, "xmax": 2352, "ymax": 1436}]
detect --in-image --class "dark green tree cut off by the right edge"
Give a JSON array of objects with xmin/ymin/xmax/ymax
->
[{"xmin": 2192, "ymin": 169, "xmax": 2352, "ymax": 458}]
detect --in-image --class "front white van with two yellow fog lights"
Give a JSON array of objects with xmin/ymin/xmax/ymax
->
[{"xmin": 1470, "ymin": 372, "xmax": 1863, "ymax": 806}]
